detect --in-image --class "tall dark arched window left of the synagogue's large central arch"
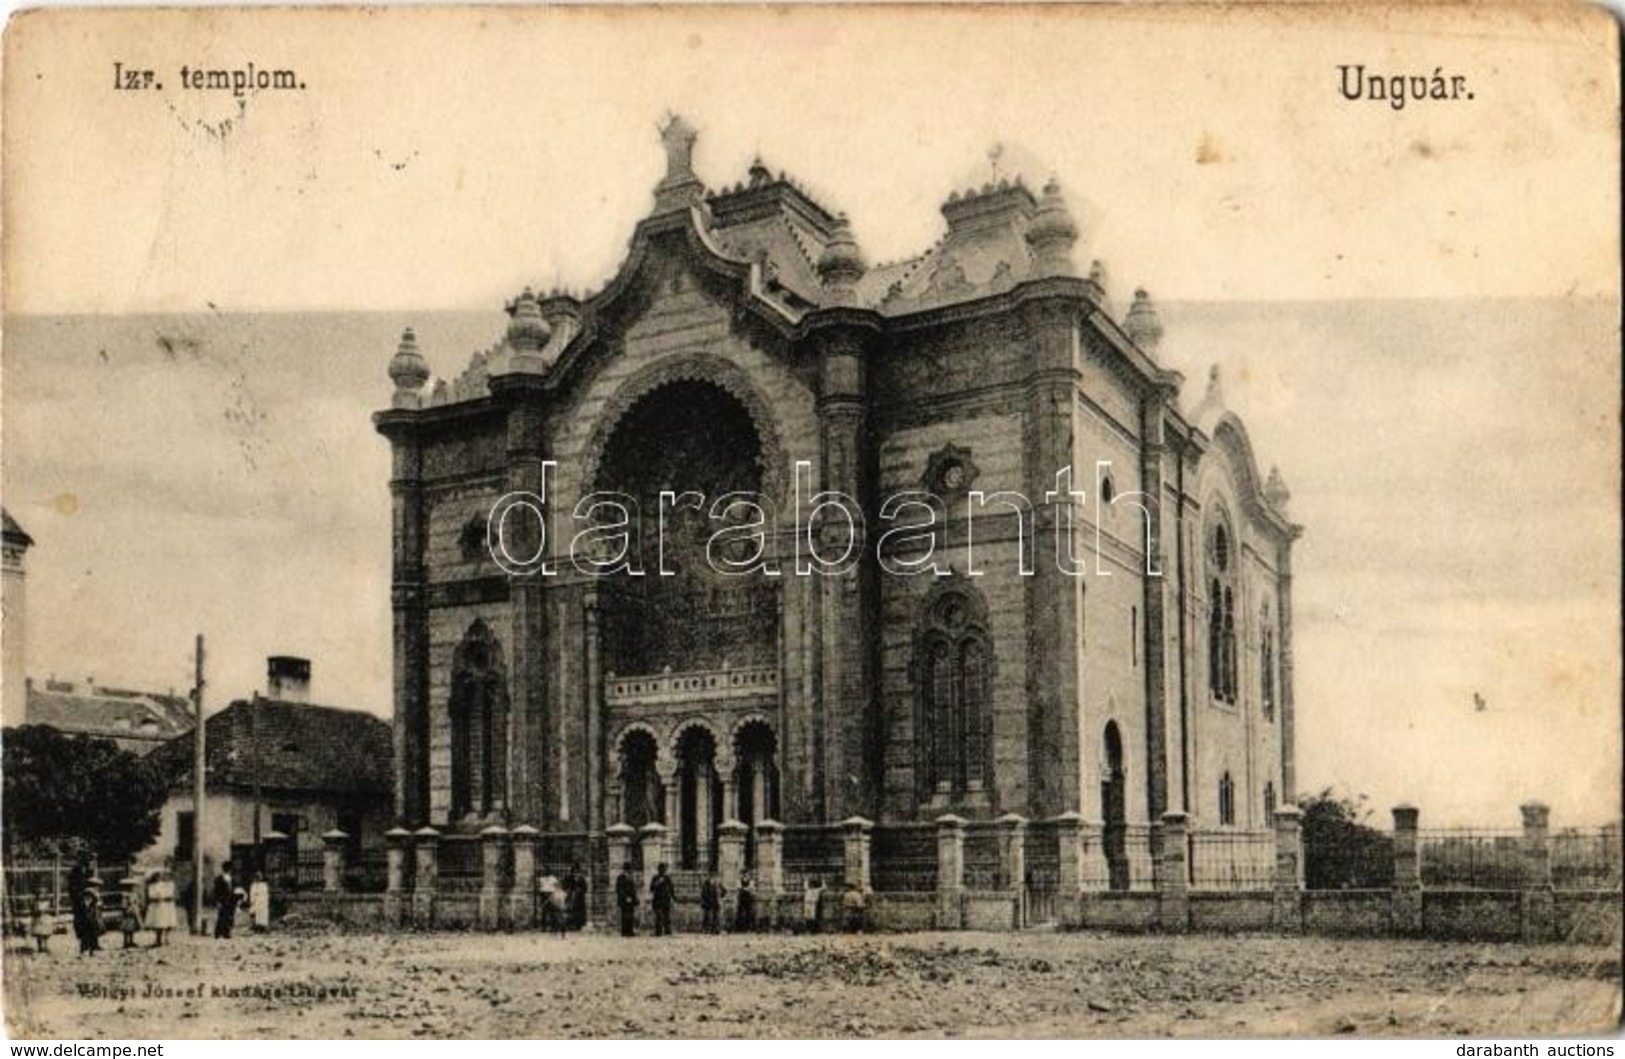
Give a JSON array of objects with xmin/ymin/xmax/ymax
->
[{"xmin": 449, "ymin": 620, "xmax": 507, "ymax": 822}]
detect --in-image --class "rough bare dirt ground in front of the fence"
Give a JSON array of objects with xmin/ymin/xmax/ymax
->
[{"xmin": 5, "ymin": 932, "xmax": 1620, "ymax": 1038}]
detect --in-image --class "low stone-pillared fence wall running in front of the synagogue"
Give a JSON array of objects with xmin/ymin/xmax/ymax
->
[{"xmin": 266, "ymin": 804, "xmax": 1625, "ymax": 944}]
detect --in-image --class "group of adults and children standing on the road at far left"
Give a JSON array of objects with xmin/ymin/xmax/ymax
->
[{"xmin": 28, "ymin": 858, "xmax": 271, "ymax": 957}]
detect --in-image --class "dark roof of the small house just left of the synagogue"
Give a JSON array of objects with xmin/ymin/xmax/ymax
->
[{"xmin": 153, "ymin": 698, "xmax": 392, "ymax": 794}]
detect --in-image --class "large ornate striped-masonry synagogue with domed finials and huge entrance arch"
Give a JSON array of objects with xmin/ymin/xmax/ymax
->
[{"xmin": 375, "ymin": 119, "xmax": 1300, "ymax": 869}]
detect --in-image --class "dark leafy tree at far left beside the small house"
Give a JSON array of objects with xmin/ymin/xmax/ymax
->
[{"xmin": 0, "ymin": 724, "xmax": 167, "ymax": 861}]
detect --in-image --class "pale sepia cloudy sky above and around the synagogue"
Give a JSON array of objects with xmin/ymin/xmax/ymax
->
[{"xmin": 0, "ymin": 8, "xmax": 1620, "ymax": 827}]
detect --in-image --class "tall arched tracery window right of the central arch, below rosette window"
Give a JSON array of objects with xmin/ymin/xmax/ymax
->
[{"xmin": 915, "ymin": 590, "xmax": 991, "ymax": 802}]
